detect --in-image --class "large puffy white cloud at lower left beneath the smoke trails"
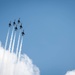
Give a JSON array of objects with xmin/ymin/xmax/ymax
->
[{"xmin": 0, "ymin": 42, "xmax": 40, "ymax": 75}]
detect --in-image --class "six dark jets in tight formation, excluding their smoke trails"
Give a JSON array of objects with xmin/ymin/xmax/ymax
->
[{"xmin": 9, "ymin": 18, "xmax": 25, "ymax": 36}]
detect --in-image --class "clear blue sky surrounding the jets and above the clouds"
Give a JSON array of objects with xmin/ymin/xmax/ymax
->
[{"xmin": 0, "ymin": 0, "xmax": 75, "ymax": 75}]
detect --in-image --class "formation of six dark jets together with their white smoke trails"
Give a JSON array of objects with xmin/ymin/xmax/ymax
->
[{"xmin": 5, "ymin": 18, "xmax": 25, "ymax": 62}]
